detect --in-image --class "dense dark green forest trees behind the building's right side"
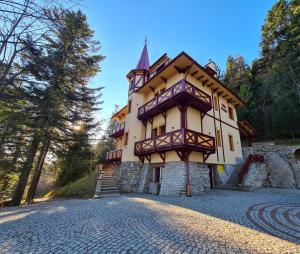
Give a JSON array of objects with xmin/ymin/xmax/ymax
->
[{"xmin": 224, "ymin": 0, "xmax": 300, "ymax": 139}]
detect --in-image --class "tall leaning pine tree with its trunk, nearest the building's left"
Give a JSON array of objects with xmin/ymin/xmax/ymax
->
[{"xmin": 12, "ymin": 10, "xmax": 103, "ymax": 205}]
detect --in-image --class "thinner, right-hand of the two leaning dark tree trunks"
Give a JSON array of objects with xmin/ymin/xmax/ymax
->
[{"xmin": 26, "ymin": 140, "xmax": 50, "ymax": 203}]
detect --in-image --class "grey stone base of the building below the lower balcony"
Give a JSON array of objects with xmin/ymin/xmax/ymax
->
[{"xmin": 114, "ymin": 162, "xmax": 210, "ymax": 196}]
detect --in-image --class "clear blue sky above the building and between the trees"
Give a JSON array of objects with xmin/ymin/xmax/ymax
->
[{"xmin": 81, "ymin": 0, "xmax": 276, "ymax": 126}]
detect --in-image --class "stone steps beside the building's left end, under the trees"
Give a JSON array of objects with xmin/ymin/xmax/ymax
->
[{"xmin": 94, "ymin": 176, "xmax": 120, "ymax": 198}]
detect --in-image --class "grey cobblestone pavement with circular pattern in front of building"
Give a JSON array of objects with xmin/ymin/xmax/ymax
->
[{"xmin": 0, "ymin": 189, "xmax": 300, "ymax": 253}]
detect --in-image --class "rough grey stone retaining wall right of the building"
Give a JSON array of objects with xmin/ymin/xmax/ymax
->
[{"xmin": 243, "ymin": 142, "xmax": 300, "ymax": 188}]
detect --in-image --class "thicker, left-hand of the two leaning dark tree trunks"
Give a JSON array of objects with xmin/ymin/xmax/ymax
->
[{"xmin": 10, "ymin": 133, "xmax": 40, "ymax": 206}]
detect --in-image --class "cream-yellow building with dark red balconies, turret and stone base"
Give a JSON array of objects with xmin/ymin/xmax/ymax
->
[{"xmin": 107, "ymin": 45, "xmax": 245, "ymax": 196}]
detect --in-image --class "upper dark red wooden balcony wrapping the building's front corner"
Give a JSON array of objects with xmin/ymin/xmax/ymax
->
[{"xmin": 138, "ymin": 79, "xmax": 212, "ymax": 121}]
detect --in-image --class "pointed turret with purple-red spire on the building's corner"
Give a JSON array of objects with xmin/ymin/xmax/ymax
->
[{"xmin": 127, "ymin": 40, "xmax": 150, "ymax": 94}]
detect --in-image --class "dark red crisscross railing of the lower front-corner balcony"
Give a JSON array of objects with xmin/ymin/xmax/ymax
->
[{"xmin": 134, "ymin": 129, "xmax": 215, "ymax": 156}]
